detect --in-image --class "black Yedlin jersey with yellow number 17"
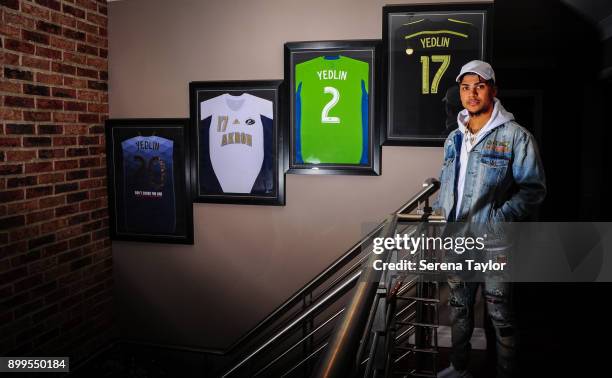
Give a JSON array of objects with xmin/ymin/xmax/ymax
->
[{"xmin": 390, "ymin": 16, "xmax": 482, "ymax": 138}]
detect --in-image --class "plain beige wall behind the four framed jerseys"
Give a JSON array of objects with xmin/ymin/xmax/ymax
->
[{"xmin": 109, "ymin": 0, "xmax": 488, "ymax": 347}]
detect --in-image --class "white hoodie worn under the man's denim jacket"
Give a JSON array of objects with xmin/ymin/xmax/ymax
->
[{"xmin": 455, "ymin": 98, "xmax": 514, "ymax": 219}]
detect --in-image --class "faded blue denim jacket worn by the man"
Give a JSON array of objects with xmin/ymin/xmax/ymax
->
[{"xmin": 434, "ymin": 99, "xmax": 546, "ymax": 223}]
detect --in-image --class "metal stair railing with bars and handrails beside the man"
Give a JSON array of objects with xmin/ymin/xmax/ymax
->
[{"xmin": 221, "ymin": 179, "xmax": 443, "ymax": 377}]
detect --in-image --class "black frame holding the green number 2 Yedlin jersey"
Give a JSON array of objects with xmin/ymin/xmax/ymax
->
[{"xmin": 284, "ymin": 40, "xmax": 382, "ymax": 175}]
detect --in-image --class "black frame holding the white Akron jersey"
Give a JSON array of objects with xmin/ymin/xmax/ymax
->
[{"xmin": 189, "ymin": 80, "xmax": 285, "ymax": 206}]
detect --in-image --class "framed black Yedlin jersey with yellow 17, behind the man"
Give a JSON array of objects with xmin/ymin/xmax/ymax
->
[{"xmin": 381, "ymin": 4, "xmax": 493, "ymax": 146}]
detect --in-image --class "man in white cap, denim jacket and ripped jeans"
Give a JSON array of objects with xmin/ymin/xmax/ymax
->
[{"xmin": 437, "ymin": 60, "xmax": 546, "ymax": 378}]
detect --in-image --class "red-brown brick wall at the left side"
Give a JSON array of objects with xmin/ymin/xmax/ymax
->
[{"xmin": 0, "ymin": 0, "xmax": 112, "ymax": 361}]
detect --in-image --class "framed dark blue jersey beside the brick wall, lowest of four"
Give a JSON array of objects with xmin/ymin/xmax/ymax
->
[{"xmin": 106, "ymin": 118, "xmax": 193, "ymax": 244}]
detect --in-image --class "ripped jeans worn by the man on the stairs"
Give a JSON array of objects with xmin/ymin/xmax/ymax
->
[{"xmin": 448, "ymin": 274, "xmax": 518, "ymax": 378}]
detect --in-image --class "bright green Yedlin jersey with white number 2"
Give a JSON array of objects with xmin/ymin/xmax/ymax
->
[{"xmin": 295, "ymin": 55, "xmax": 369, "ymax": 164}]
